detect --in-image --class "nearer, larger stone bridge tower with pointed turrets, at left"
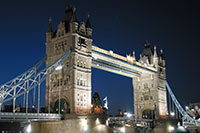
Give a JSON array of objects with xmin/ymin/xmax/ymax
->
[{"xmin": 45, "ymin": 6, "xmax": 92, "ymax": 114}]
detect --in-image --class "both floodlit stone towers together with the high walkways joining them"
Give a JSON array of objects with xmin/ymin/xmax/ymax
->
[{"xmin": 45, "ymin": 7, "xmax": 167, "ymax": 119}]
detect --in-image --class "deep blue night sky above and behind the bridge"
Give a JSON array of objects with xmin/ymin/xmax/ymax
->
[{"xmin": 0, "ymin": 0, "xmax": 200, "ymax": 114}]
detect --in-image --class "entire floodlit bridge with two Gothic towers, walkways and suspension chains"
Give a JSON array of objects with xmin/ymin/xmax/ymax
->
[{"xmin": 0, "ymin": 4, "xmax": 200, "ymax": 132}]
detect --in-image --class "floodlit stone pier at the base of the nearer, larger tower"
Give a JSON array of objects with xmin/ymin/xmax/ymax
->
[{"xmin": 31, "ymin": 114, "xmax": 112, "ymax": 133}]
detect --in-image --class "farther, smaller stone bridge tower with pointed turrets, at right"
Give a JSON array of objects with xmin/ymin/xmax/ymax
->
[{"xmin": 133, "ymin": 41, "xmax": 167, "ymax": 119}]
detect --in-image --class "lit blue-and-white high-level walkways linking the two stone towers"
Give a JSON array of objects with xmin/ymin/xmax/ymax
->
[{"xmin": 92, "ymin": 46, "xmax": 157, "ymax": 78}]
